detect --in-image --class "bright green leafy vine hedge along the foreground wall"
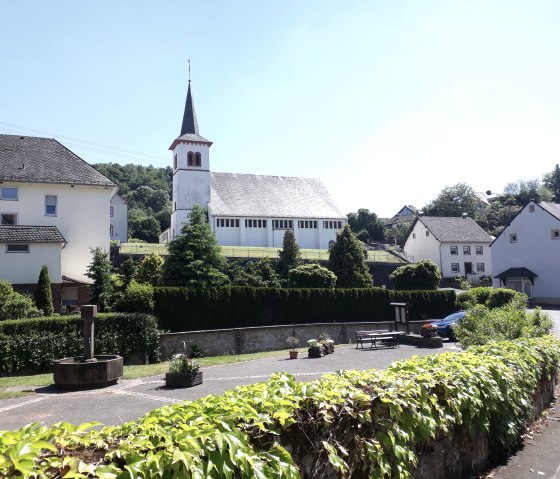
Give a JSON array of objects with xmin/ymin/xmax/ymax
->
[{"xmin": 0, "ymin": 336, "xmax": 560, "ymax": 479}]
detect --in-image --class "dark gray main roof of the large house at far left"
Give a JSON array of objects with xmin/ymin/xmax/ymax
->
[{"xmin": 0, "ymin": 135, "xmax": 115, "ymax": 186}]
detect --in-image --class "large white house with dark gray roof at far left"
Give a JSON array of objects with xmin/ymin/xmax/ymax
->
[{"xmin": 0, "ymin": 135, "xmax": 117, "ymax": 309}]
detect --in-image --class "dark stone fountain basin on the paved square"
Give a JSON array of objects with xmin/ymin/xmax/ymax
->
[{"xmin": 53, "ymin": 354, "xmax": 123, "ymax": 389}]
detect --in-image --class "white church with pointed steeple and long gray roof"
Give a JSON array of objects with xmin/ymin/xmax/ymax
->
[{"xmin": 160, "ymin": 80, "xmax": 347, "ymax": 249}]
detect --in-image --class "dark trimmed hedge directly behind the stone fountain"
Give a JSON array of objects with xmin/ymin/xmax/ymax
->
[{"xmin": 0, "ymin": 313, "xmax": 159, "ymax": 375}]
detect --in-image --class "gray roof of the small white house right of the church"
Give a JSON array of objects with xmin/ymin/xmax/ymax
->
[{"xmin": 417, "ymin": 216, "xmax": 492, "ymax": 243}]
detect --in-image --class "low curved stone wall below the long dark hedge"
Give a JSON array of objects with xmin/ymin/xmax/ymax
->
[{"xmin": 160, "ymin": 321, "xmax": 395, "ymax": 360}]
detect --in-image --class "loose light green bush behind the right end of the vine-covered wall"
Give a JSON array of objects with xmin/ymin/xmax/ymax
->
[{"xmin": 454, "ymin": 295, "xmax": 553, "ymax": 348}]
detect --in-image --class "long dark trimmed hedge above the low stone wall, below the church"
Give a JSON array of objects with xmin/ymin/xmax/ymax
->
[{"xmin": 154, "ymin": 287, "xmax": 457, "ymax": 331}]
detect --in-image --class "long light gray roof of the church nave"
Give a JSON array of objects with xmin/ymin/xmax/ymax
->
[{"xmin": 209, "ymin": 173, "xmax": 346, "ymax": 219}]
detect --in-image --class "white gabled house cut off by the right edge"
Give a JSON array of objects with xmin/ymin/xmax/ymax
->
[{"xmin": 491, "ymin": 201, "xmax": 560, "ymax": 304}]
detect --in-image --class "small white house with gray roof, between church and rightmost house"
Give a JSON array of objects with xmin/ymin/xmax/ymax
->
[{"xmin": 404, "ymin": 216, "xmax": 492, "ymax": 281}]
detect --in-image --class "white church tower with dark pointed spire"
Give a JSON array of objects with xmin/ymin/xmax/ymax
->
[{"xmin": 169, "ymin": 83, "xmax": 212, "ymax": 239}]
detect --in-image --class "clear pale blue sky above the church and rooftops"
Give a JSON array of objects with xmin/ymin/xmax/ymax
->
[{"xmin": 0, "ymin": 0, "xmax": 560, "ymax": 217}]
